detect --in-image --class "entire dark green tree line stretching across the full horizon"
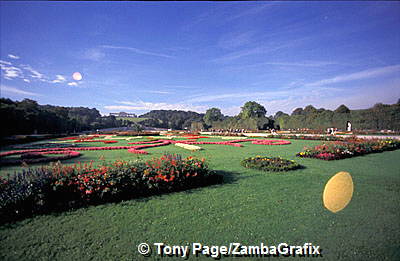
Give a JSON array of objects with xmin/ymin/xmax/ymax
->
[{"xmin": 0, "ymin": 98, "xmax": 400, "ymax": 136}]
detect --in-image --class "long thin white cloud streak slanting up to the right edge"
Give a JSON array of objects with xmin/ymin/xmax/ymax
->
[{"xmin": 304, "ymin": 65, "xmax": 400, "ymax": 87}]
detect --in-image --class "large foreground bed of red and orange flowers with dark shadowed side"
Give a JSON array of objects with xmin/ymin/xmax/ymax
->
[{"xmin": 0, "ymin": 155, "xmax": 221, "ymax": 223}]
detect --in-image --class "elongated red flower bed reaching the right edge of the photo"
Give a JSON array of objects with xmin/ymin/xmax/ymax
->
[{"xmin": 296, "ymin": 139, "xmax": 400, "ymax": 160}]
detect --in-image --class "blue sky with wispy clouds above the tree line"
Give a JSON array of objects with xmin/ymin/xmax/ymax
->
[{"xmin": 0, "ymin": 1, "xmax": 400, "ymax": 115}]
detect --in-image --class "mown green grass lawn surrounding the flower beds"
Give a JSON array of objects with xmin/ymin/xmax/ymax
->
[{"xmin": 0, "ymin": 139, "xmax": 400, "ymax": 260}]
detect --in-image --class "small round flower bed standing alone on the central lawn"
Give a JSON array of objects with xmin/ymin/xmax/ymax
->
[{"xmin": 241, "ymin": 156, "xmax": 301, "ymax": 171}]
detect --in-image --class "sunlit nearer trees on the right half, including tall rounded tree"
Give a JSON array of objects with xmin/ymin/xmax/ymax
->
[{"xmin": 188, "ymin": 99, "xmax": 400, "ymax": 131}]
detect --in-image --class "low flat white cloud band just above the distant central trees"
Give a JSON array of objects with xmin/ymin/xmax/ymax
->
[{"xmin": 104, "ymin": 101, "xmax": 208, "ymax": 112}]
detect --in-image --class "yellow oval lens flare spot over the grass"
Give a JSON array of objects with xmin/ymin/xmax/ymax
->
[{"xmin": 323, "ymin": 171, "xmax": 354, "ymax": 213}]
